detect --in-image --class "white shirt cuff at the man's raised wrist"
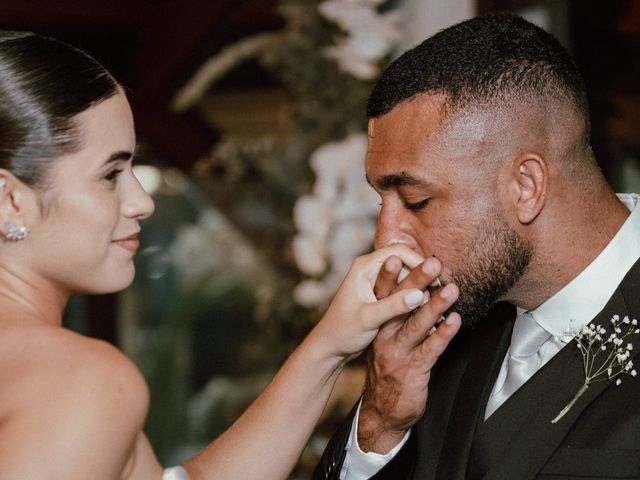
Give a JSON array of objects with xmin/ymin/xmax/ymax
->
[{"xmin": 340, "ymin": 400, "xmax": 411, "ymax": 480}]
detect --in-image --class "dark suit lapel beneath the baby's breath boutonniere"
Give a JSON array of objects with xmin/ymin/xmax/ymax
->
[{"xmin": 484, "ymin": 262, "xmax": 640, "ymax": 480}]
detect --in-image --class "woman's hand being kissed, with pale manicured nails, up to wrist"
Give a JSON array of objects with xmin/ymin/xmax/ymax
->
[{"xmin": 309, "ymin": 245, "xmax": 427, "ymax": 361}]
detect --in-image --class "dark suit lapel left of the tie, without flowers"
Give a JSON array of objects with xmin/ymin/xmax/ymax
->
[{"xmin": 430, "ymin": 304, "xmax": 515, "ymax": 480}]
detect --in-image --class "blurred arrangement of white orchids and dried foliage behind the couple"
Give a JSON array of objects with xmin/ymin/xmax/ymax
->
[{"xmin": 173, "ymin": 0, "xmax": 401, "ymax": 314}]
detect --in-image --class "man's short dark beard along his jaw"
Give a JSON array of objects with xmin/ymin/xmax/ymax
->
[{"xmin": 447, "ymin": 213, "xmax": 533, "ymax": 326}]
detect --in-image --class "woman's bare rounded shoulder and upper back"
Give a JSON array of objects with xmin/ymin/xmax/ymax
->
[{"xmin": 0, "ymin": 316, "xmax": 149, "ymax": 478}]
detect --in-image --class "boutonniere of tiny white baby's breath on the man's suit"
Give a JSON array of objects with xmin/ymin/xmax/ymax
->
[{"xmin": 551, "ymin": 315, "xmax": 640, "ymax": 423}]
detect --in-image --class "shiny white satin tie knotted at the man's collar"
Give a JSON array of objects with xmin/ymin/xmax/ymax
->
[{"xmin": 485, "ymin": 312, "xmax": 551, "ymax": 418}]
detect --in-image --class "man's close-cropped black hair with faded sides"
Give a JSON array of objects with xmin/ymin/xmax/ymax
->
[{"xmin": 367, "ymin": 13, "xmax": 589, "ymax": 137}]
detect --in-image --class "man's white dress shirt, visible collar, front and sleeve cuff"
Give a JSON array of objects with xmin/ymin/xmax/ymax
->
[{"xmin": 340, "ymin": 193, "xmax": 640, "ymax": 480}]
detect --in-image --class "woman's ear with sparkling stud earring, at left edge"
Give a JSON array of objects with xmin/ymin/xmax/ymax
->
[{"xmin": 0, "ymin": 168, "xmax": 31, "ymax": 241}]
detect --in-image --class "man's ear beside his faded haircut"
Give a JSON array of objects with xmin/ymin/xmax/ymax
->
[{"xmin": 509, "ymin": 152, "xmax": 549, "ymax": 225}]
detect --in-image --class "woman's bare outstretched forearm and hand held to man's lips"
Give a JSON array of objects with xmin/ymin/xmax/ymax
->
[{"xmin": 184, "ymin": 245, "xmax": 426, "ymax": 480}]
